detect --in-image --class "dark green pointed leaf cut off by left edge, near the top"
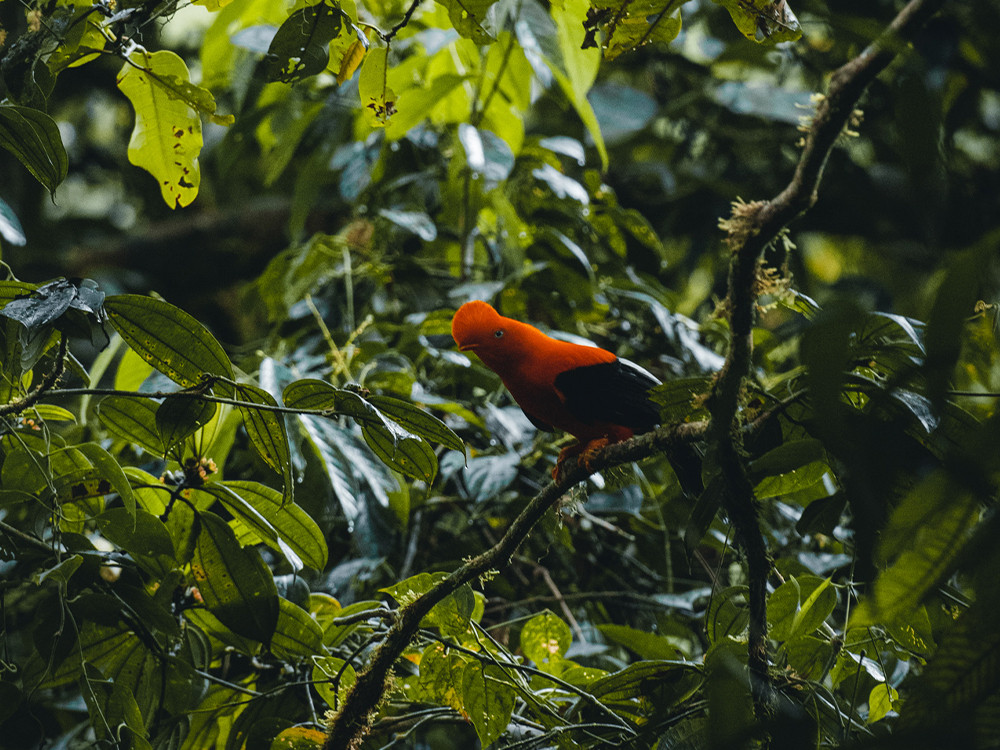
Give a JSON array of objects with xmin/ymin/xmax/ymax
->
[{"xmin": 0, "ymin": 104, "xmax": 69, "ymax": 195}]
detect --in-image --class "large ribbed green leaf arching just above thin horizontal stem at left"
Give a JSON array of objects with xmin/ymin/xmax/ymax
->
[{"xmin": 104, "ymin": 294, "xmax": 233, "ymax": 388}]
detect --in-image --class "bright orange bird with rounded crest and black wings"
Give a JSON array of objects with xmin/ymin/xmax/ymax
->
[{"xmin": 451, "ymin": 300, "xmax": 660, "ymax": 479}]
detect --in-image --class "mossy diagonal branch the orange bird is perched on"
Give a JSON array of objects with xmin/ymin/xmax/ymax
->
[{"xmin": 324, "ymin": 422, "xmax": 708, "ymax": 750}]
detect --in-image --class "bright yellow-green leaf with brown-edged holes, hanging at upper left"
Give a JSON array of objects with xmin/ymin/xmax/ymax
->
[{"xmin": 118, "ymin": 49, "xmax": 202, "ymax": 208}]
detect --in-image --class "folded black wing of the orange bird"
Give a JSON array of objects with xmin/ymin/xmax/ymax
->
[{"xmin": 555, "ymin": 359, "xmax": 660, "ymax": 432}]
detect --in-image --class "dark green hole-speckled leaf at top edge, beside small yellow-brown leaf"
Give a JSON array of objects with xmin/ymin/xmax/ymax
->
[{"xmin": 267, "ymin": 0, "xmax": 343, "ymax": 83}]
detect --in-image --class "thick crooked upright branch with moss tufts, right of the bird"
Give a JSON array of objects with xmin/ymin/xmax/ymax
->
[{"xmin": 710, "ymin": 0, "xmax": 944, "ymax": 719}]
